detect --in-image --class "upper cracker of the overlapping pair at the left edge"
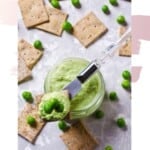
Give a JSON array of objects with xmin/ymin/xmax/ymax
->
[{"xmin": 18, "ymin": 39, "xmax": 43, "ymax": 69}]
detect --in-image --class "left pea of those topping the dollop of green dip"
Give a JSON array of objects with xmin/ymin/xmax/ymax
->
[{"xmin": 44, "ymin": 98, "xmax": 58, "ymax": 114}]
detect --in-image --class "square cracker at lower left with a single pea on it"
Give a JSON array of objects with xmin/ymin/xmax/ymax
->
[{"xmin": 18, "ymin": 95, "xmax": 46, "ymax": 143}]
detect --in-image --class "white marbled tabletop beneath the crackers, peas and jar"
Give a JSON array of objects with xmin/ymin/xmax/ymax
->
[{"xmin": 18, "ymin": 0, "xmax": 131, "ymax": 150}]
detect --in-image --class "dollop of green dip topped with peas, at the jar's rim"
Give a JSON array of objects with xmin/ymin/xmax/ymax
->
[{"xmin": 39, "ymin": 91, "xmax": 70, "ymax": 121}]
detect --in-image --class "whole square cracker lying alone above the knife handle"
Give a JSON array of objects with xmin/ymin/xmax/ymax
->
[{"xmin": 73, "ymin": 12, "xmax": 107, "ymax": 47}]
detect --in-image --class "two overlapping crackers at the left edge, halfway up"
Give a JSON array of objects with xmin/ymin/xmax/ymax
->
[{"xmin": 18, "ymin": 39, "xmax": 43, "ymax": 83}]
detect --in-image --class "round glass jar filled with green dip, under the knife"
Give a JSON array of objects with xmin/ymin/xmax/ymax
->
[{"xmin": 44, "ymin": 58, "xmax": 105, "ymax": 119}]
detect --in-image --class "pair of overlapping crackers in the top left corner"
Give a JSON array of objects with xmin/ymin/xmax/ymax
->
[{"xmin": 19, "ymin": 0, "xmax": 68, "ymax": 36}]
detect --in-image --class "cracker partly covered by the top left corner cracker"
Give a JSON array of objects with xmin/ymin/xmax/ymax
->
[{"xmin": 36, "ymin": 6, "xmax": 68, "ymax": 36}]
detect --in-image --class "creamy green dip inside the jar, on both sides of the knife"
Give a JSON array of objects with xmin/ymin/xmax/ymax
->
[{"xmin": 45, "ymin": 58, "xmax": 101, "ymax": 112}]
